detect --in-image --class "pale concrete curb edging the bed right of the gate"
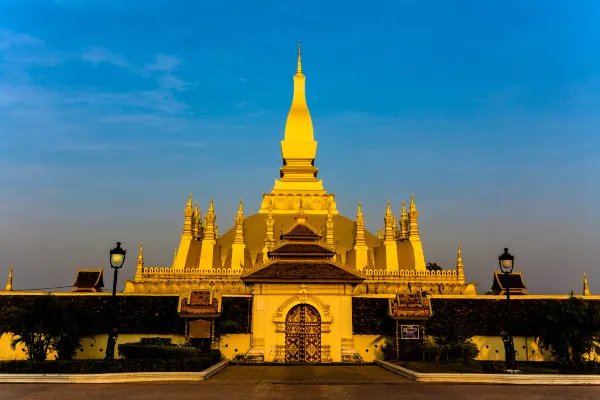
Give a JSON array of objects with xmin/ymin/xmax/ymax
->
[{"xmin": 375, "ymin": 360, "xmax": 600, "ymax": 385}]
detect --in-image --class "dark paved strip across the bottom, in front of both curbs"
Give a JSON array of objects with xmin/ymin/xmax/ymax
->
[{"xmin": 0, "ymin": 383, "xmax": 600, "ymax": 400}]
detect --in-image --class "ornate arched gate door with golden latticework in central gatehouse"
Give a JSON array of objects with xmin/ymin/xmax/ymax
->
[{"xmin": 285, "ymin": 304, "xmax": 321, "ymax": 363}]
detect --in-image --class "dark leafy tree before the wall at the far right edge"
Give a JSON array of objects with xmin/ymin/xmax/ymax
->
[{"xmin": 537, "ymin": 292, "xmax": 600, "ymax": 368}]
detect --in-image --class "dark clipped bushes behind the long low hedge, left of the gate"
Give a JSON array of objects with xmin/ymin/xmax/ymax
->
[{"xmin": 118, "ymin": 342, "xmax": 211, "ymax": 360}]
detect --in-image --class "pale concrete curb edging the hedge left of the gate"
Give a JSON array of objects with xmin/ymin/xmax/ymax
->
[{"xmin": 0, "ymin": 360, "xmax": 229, "ymax": 383}]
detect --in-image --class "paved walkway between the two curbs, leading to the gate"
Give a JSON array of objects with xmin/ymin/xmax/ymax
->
[{"xmin": 206, "ymin": 365, "xmax": 416, "ymax": 385}]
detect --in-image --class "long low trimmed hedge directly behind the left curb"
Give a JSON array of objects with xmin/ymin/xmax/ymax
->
[{"xmin": 0, "ymin": 351, "xmax": 221, "ymax": 374}]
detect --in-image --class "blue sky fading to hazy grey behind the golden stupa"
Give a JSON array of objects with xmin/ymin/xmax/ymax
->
[{"xmin": 0, "ymin": 0, "xmax": 600, "ymax": 294}]
